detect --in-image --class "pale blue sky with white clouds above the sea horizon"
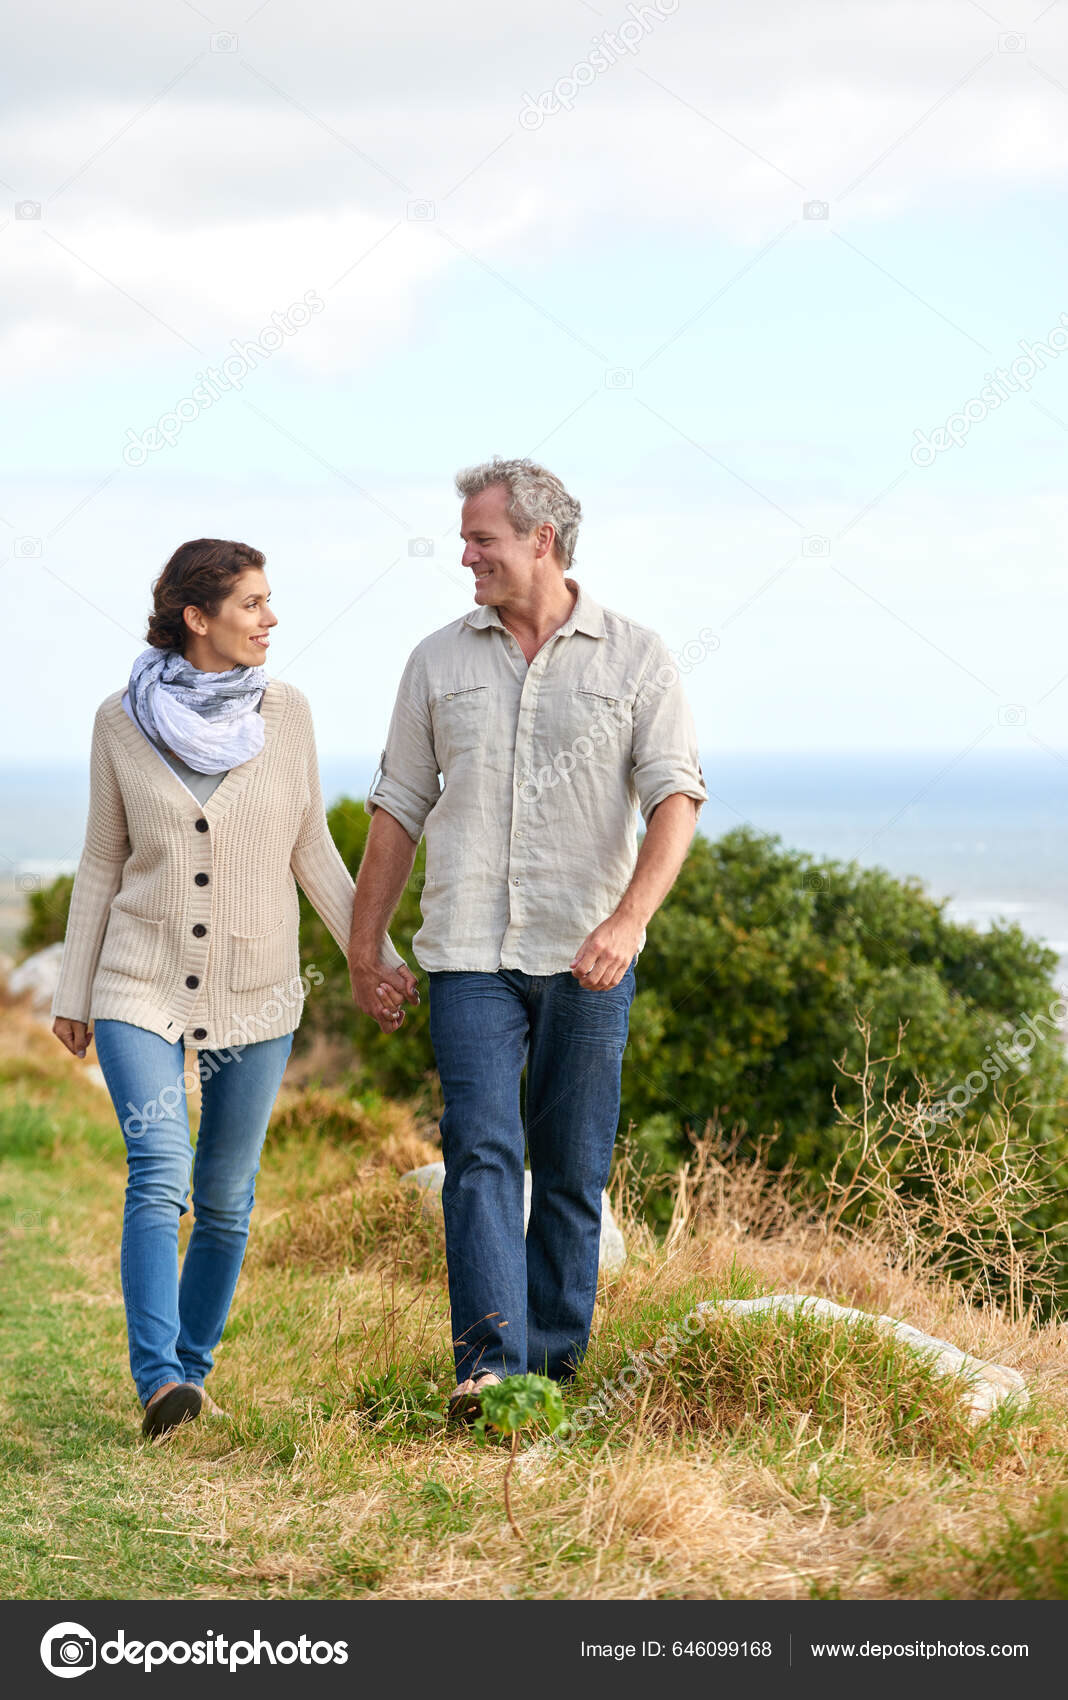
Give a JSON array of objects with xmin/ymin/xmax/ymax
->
[{"xmin": 0, "ymin": 0, "xmax": 1068, "ymax": 782}]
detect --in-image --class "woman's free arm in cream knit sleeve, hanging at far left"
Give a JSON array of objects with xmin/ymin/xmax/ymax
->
[{"xmin": 51, "ymin": 712, "xmax": 129, "ymax": 1056}]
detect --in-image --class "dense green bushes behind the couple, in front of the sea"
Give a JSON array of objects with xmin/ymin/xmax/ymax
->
[{"xmin": 24, "ymin": 816, "xmax": 1068, "ymax": 1244}]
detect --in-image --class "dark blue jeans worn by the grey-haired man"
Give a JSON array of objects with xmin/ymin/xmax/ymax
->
[{"xmin": 429, "ymin": 957, "xmax": 638, "ymax": 1382}]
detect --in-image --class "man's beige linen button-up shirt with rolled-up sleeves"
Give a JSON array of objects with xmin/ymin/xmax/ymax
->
[{"xmin": 366, "ymin": 578, "xmax": 707, "ymax": 974}]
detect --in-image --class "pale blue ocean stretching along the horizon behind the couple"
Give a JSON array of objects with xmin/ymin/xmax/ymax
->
[{"xmin": 0, "ymin": 750, "xmax": 1068, "ymax": 976}]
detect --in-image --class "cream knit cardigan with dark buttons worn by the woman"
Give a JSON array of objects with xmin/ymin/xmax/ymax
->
[{"xmin": 51, "ymin": 678, "xmax": 403, "ymax": 1051}]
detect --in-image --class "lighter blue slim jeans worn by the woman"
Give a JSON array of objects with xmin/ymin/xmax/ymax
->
[{"xmin": 94, "ymin": 1022, "xmax": 293, "ymax": 1404}]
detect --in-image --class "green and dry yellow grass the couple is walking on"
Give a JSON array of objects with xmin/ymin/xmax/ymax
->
[{"xmin": 0, "ymin": 1008, "xmax": 1068, "ymax": 1600}]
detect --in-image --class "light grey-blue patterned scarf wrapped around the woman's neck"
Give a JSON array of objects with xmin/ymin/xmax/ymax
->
[{"xmin": 129, "ymin": 649, "xmax": 267, "ymax": 774}]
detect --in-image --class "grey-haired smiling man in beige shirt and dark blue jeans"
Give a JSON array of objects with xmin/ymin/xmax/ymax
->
[{"xmin": 350, "ymin": 459, "xmax": 707, "ymax": 1418}]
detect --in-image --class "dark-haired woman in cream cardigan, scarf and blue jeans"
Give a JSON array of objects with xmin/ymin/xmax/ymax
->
[{"xmin": 51, "ymin": 539, "xmax": 418, "ymax": 1435}]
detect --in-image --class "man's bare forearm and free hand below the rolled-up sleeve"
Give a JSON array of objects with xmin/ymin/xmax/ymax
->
[{"xmin": 571, "ymin": 792, "xmax": 697, "ymax": 991}]
